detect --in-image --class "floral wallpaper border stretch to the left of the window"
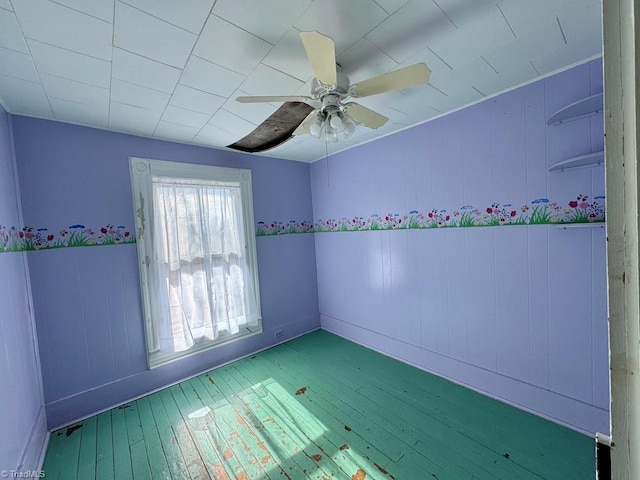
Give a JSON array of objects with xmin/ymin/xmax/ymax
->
[{"xmin": 0, "ymin": 223, "xmax": 136, "ymax": 253}]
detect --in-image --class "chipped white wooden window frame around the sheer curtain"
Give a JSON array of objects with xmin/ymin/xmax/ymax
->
[{"xmin": 129, "ymin": 157, "xmax": 262, "ymax": 369}]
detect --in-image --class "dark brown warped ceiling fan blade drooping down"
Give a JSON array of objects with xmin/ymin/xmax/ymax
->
[{"xmin": 227, "ymin": 102, "xmax": 313, "ymax": 153}]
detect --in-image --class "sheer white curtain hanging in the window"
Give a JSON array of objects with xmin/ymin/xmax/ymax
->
[{"xmin": 152, "ymin": 177, "xmax": 259, "ymax": 352}]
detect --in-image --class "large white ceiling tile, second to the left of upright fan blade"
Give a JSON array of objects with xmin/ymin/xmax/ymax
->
[{"xmin": 193, "ymin": 15, "xmax": 271, "ymax": 75}]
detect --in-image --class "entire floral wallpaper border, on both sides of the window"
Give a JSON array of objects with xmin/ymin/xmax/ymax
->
[{"xmin": 0, "ymin": 194, "xmax": 605, "ymax": 253}]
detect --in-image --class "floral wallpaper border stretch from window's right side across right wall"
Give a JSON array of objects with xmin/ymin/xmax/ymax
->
[{"xmin": 256, "ymin": 194, "xmax": 605, "ymax": 237}]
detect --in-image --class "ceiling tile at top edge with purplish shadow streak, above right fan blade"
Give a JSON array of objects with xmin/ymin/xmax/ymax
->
[{"xmin": 367, "ymin": 0, "xmax": 455, "ymax": 63}]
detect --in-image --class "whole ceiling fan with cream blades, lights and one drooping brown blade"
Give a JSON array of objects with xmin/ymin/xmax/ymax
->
[{"xmin": 228, "ymin": 31, "xmax": 431, "ymax": 152}]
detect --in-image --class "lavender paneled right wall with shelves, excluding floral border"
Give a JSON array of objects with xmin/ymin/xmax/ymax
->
[{"xmin": 311, "ymin": 61, "xmax": 609, "ymax": 433}]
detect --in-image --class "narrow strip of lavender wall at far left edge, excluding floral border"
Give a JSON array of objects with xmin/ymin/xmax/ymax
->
[{"xmin": 0, "ymin": 107, "xmax": 47, "ymax": 471}]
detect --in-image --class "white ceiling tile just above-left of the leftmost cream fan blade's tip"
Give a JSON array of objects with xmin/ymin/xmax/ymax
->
[{"xmin": 180, "ymin": 55, "xmax": 245, "ymax": 97}]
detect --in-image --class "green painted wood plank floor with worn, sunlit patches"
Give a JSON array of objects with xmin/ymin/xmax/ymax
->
[{"xmin": 44, "ymin": 331, "xmax": 595, "ymax": 480}]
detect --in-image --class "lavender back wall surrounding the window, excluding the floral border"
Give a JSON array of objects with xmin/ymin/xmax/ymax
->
[{"xmin": 14, "ymin": 117, "xmax": 319, "ymax": 427}]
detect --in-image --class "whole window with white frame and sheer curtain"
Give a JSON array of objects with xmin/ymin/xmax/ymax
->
[{"xmin": 130, "ymin": 158, "xmax": 262, "ymax": 368}]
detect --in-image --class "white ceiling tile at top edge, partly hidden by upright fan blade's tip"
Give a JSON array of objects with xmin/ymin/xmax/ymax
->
[{"xmin": 294, "ymin": 0, "xmax": 388, "ymax": 53}]
